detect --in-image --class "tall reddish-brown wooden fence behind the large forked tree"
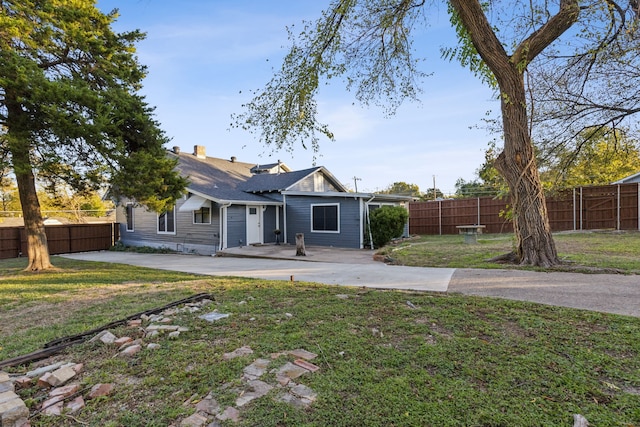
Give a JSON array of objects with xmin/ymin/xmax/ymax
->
[{"xmin": 409, "ymin": 183, "xmax": 640, "ymax": 234}]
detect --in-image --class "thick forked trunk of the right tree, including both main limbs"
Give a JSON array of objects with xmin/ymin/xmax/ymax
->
[{"xmin": 451, "ymin": 0, "xmax": 580, "ymax": 267}]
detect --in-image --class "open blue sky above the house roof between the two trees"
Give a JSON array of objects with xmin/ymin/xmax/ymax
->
[{"xmin": 98, "ymin": 0, "xmax": 499, "ymax": 193}]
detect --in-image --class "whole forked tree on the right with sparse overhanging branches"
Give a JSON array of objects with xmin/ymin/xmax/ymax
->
[{"xmin": 234, "ymin": 0, "xmax": 640, "ymax": 266}]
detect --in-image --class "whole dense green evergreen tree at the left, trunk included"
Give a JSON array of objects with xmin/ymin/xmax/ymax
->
[{"xmin": 0, "ymin": 0, "xmax": 186, "ymax": 270}]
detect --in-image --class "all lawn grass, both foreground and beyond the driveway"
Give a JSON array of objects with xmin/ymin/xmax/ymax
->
[{"xmin": 0, "ymin": 233, "xmax": 640, "ymax": 427}]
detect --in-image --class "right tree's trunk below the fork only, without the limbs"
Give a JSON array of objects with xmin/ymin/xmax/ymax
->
[{"xmin": 495, "ymin": 74, "xmax": 558, "ymax": 267}]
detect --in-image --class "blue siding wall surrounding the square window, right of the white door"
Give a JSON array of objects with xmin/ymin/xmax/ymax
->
[{"xmin": 286, "ymin": 196, "xmax": 361, "ymax": 249}]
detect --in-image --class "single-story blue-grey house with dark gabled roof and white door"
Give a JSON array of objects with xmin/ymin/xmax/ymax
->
[{"xmin": 116, "ymin": 145, "xmax": 411, "ymax": 255}]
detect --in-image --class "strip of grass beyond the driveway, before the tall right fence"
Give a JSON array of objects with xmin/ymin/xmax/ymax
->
[{"xmin": 382, "ymin": 231, "xmax": 640, "ymax": 274}]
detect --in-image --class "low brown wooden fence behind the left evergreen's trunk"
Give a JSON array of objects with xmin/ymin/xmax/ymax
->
[{"xmin": 0, "ymin": 223, "xmax": 120, "ymax": 259}]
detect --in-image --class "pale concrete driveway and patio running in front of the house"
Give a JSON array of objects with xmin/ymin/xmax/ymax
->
[{"xmin": 65, "ymin": 245, "xmax": 640, "ymax": 317}]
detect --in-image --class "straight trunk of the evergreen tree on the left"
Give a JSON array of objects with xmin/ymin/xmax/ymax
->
[{"xmin": 5, "ymin": 93, "xmax": 53, "ymax": 271}]
